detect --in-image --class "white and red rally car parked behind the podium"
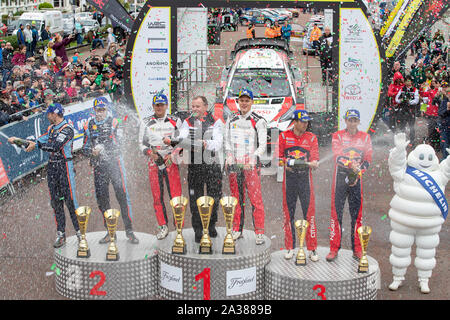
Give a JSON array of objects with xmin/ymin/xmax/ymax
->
[{"xmin": 214, "ymin": 38, "xmax": 304, "ymax": 157}]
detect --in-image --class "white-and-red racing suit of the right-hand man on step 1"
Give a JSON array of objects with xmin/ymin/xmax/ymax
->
[{"xmin": 225, "ymin": 112, "xmax": 267, "ymax": 234}]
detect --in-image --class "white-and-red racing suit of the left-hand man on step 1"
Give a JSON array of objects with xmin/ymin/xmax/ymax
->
[{"xmin": 139, "ymin": 115, "xmax": 181, "ymax": 226}]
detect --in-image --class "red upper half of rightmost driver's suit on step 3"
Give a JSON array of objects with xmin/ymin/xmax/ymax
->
[{"xmin": 331, "ymin": 129, "xmax": 372, "ymax": 169}]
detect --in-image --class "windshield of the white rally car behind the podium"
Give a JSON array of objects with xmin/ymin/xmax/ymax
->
[{"xmin": 228, "ymin": 69, "xmax": 291, "ymax": 98}]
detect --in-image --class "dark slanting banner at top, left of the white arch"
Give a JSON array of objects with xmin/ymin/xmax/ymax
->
[{"xmin": 87, "ymin": 0, "xmax": 134, "ymax": 32}]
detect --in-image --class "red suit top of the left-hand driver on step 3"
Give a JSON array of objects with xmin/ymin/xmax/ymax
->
[{"xmin": 278, "ymin": 129, "xmax": 319, "ymax": 162}]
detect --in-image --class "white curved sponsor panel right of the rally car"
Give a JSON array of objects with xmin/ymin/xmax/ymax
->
[{"xmin": 338, "ymin": 8, "xmax": 382, "ymax": 131}]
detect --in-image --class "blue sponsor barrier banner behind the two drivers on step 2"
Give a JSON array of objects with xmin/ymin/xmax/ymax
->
[{"xmin": 0, "ymin": 96, "xmax": 114, "ymax": 182}]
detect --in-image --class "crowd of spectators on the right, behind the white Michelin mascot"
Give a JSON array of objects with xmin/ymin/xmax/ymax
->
[{"xmin": 385, "ymin": 30, "xmax": 450, "ymax": 157}]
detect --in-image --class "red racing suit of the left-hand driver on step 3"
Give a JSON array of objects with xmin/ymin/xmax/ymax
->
[{"xmin": 278, "ymin": 130, "xmax": 319, "ymax": 251}]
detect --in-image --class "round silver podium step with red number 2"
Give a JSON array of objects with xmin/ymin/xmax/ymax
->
[{"xmin": 55, "ymin": 231, "xmax": 158, "ymax": 300}]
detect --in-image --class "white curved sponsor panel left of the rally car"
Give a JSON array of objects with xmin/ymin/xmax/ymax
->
[{"xmin": 130, "ymin": 7, "xmax": 171, "ymax": 119}]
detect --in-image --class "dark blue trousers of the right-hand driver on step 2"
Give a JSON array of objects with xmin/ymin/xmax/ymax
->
[{"xmin": 94, "ymin": 157, "xmax": 132, "ymax": 230}]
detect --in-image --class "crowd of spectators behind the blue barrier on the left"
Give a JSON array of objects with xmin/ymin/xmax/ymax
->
[{"xmin": 0, "ymin": 30, "xmax": 124, "ymax": 126}]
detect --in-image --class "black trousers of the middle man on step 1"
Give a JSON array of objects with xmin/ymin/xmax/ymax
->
[{"xmin": 188, "ymin": 164, "xmax": 222, "ymax": 233}]
